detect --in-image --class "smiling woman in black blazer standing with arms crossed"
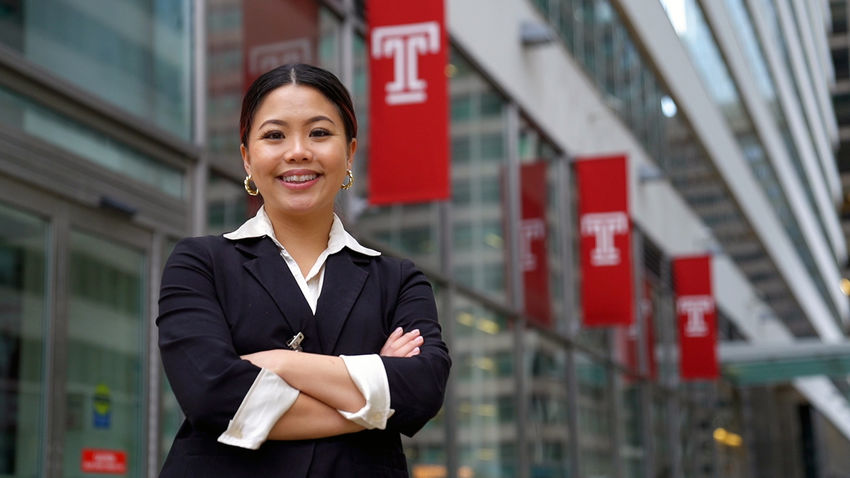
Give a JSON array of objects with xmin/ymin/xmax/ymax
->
[{"xmin": 157, "ymin": 64, "xmax": 451, "ymax": 478}]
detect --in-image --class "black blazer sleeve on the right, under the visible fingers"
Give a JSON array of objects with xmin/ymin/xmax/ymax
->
[{"xmin": 381, "ymin": 260, "xmax": 451, "ymax": 436}]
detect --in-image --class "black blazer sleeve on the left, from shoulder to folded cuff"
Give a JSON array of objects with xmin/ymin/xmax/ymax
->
[{"xmin": 156, "ymin": 237, "xmax": 260, "ymax": 434}]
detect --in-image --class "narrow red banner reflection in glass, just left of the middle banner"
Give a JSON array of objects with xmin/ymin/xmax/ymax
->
[{"xmin": 519, "ymin": 161, "xmax": 552, "ymax": 326}]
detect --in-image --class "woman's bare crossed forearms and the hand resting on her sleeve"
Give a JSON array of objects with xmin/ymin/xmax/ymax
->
[{"xmin": 242, "ymin": 328, "xmax": 423, "ymax": 440}]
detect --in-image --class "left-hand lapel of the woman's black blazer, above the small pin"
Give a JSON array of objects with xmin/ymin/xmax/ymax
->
[{"xmin": 236, "ymin": 237, "xmax": 316, "ymax": 349}]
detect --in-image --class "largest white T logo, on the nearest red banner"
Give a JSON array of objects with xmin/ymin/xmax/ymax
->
[{"xmin": 372, "ymin": 22, "xmax": 440, "ymax": 105}]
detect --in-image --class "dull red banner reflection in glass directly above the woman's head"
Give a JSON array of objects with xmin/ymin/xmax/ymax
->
[{"xmin": 242, "ymin": 0, "xmax": 319, "ymax": 91}]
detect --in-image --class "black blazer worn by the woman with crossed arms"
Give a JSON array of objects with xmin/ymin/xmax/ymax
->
[{"xmin": 157, "ymin": 236, "xmax": 451, "ymax": 478}]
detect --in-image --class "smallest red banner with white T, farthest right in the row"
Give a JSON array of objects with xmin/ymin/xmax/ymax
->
[{"xmin": 673, "ymin": 256, "xmax": 719, "ymax": 380}]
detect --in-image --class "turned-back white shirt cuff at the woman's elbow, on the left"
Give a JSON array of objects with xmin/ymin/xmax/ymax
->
[{"xmin": 218, "ymin": 369, "xmax": 299, "ymax": 450}]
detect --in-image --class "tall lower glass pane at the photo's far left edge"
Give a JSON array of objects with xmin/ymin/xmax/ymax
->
[{"xmin": 0, "ymin": 204, "xmax": 48, "ymax": 477}]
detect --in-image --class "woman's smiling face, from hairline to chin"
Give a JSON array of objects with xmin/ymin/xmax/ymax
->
[{"xmin": 241, "ymin": 85, "xmax": 357, "ymax": 220}]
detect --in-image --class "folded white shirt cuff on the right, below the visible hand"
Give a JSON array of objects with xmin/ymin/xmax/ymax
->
[{"xmin": 338, "ymin": 354, "xmax": 395, "ymax": 430}]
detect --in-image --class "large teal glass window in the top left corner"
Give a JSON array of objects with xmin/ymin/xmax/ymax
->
[{"xmin": 0, "ymin": 0, "xmax": 193, "ymax": 139}]
